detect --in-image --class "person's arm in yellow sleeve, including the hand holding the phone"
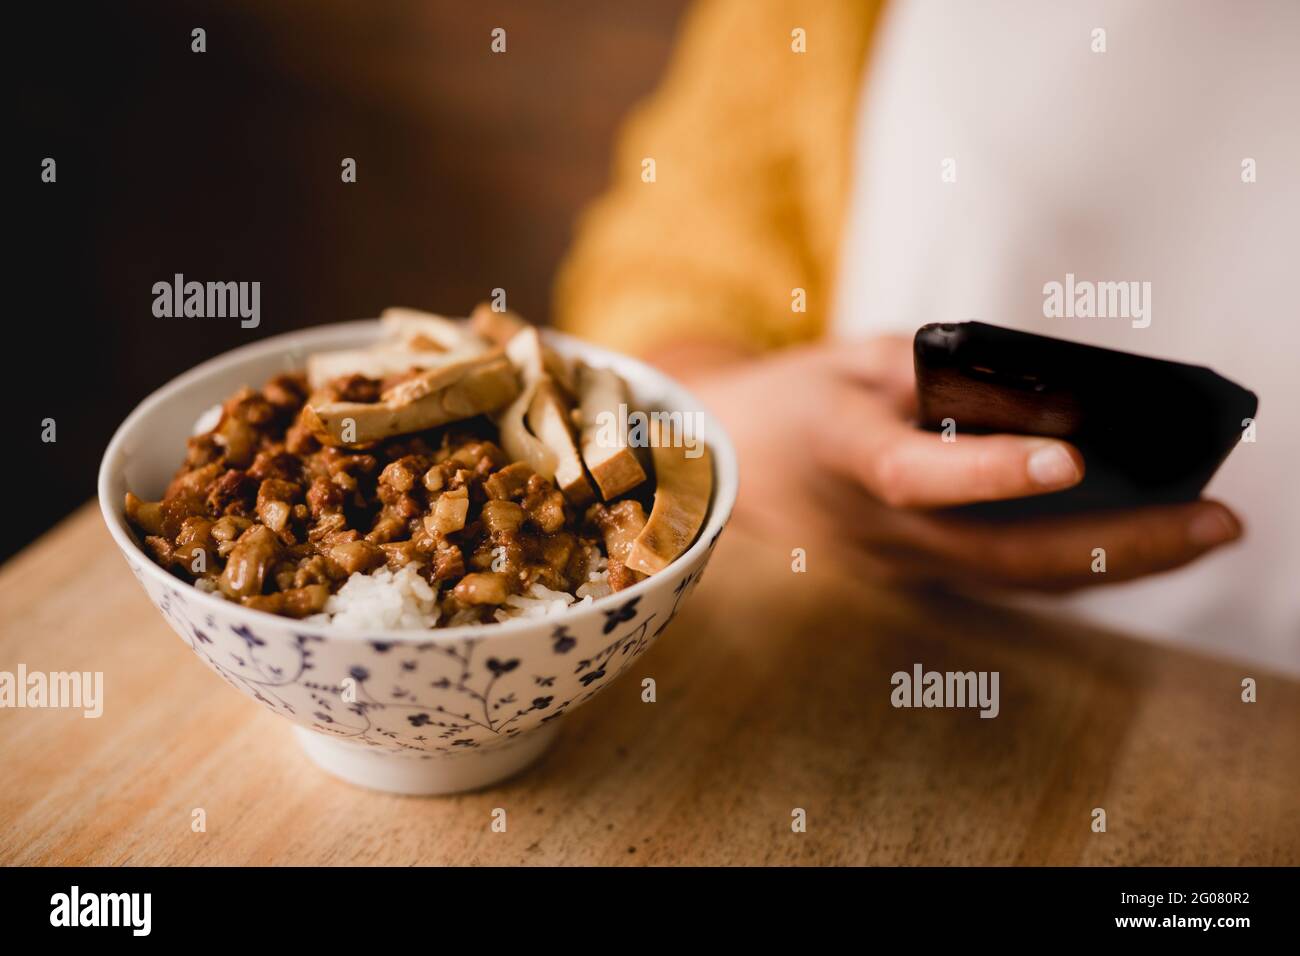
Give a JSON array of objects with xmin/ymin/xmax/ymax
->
[{"xmin": 556, "ymin": 0, "xmax": 1242, "ymax": 591}]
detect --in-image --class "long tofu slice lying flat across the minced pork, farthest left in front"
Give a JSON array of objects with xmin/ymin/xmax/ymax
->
[{"xmin": 303, "ymin": 351, "xmax": 520, "ymax": 445}]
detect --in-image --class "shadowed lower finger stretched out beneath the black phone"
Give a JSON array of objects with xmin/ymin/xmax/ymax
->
[{"xmin": 905, "ymin": 501, "xmax": 1242, "ymax": 591}]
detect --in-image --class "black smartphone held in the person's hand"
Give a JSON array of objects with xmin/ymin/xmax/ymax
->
[{"xmin": 913, "ymin": 323, "xmax": 1258, "ymax": 518}]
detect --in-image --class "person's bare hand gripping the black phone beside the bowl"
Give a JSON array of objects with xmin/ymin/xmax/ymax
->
[{"xmin": 657, "ymin": 337, "xmax": 1242, "ymax": 591}]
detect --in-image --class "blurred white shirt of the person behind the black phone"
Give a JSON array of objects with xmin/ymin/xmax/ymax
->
[{"xmin": 833, "ymin": 0, "xmax": 1300, "ymax": 674}]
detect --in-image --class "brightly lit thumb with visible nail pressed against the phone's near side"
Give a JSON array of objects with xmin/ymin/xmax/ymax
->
[{"xmin": 820, "ymin": 382, "xmax": 1083, "ymax": 509}]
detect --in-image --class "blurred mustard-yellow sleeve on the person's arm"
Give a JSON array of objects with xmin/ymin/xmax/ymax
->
[{"xmin": 555, "ymin": 0, "xmax": 875, "ymax": 352}]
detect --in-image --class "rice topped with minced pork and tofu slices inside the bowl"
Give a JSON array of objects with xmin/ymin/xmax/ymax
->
[{"xmin": 125, "ymin": 307, "xmax": 711, "ymax": 631}]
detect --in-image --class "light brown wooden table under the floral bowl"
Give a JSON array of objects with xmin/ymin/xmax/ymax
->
[{"xmin": 0, "ymin": 506, "xmax": 1300, "ymax": 865}]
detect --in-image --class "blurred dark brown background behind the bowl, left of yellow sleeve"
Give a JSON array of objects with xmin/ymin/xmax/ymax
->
[{"xmin": 12, "ymin": 0, "xmax": 686, "ymax": 558}]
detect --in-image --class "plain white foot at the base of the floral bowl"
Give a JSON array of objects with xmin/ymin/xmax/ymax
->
[{"xmin": 294, "ymin": 723, "xmax": 559, "ymax": 796}]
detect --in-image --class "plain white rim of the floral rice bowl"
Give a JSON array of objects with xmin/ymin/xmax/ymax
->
[{"xmin": 96, "ymin": 319, "xmax": 740, "ymax": 644}]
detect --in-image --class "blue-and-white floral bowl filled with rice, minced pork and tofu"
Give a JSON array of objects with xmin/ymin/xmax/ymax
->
[{"xmin": 98, "ymin": 312, "xmax": 738, "ymax": 793}]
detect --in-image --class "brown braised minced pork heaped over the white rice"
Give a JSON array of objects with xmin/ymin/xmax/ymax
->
[{"xmin": 126, "ymin": 375, "xmax": 618, "ymax": 629}]
